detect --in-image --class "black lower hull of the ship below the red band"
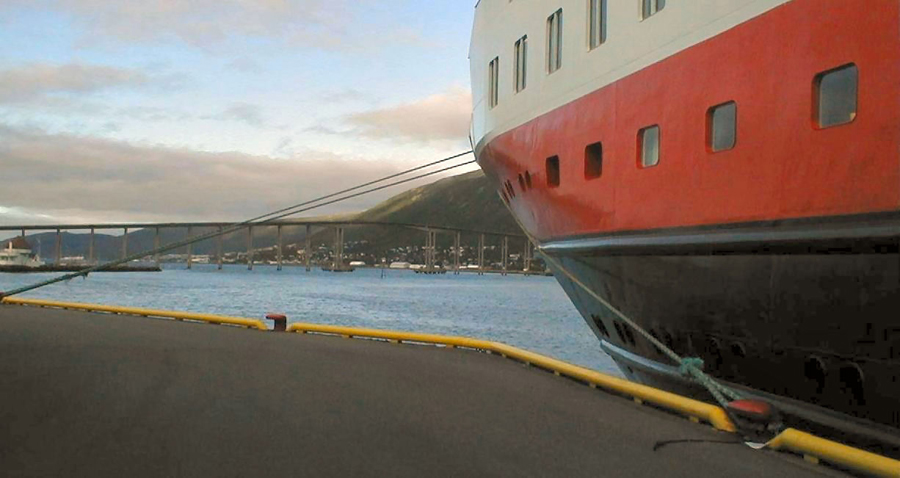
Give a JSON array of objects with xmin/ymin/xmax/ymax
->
[{"xmin": 542, "ymin": 213, "xmax": 900, "ymax": 444}]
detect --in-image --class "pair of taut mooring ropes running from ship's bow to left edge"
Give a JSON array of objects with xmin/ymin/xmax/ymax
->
[{"xmin": 0, "ymin": 151, "xmax": 475, "ymax": 299}]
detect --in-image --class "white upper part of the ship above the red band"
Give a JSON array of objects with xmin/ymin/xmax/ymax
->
[{"xmin": 469, "ymin": 0, "xmax": 792, "ymax": 149}]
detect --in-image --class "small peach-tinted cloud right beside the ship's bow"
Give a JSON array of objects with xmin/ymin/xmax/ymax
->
[{"xmin": 345, "ymin": 87, "xmax": 472, "ymax": 142}]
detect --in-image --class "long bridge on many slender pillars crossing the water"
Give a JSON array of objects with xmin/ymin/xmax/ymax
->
[{"xmin": 0, "ymin": 219, "xmax": 534, "ymax": 275}]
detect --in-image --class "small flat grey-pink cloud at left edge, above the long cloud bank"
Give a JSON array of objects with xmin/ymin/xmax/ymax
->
[{"xmin": 0, "ymin": 63, "xmax": 162, "ymax": 104}]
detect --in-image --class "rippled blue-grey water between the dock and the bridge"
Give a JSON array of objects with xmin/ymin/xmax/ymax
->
[{"xmin": 0, "ymin": 265, "xmax": 619, "ymax": 375}]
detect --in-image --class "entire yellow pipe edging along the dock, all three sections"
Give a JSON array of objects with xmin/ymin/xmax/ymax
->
[{"xmin": 0, "ymin": 297, "xmax": 900, "ymax": 478}]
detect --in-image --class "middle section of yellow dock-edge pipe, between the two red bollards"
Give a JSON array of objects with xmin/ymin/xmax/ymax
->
[{"xmin": 288, "ymin": 323, "xmax": 735, "ymax": 432}]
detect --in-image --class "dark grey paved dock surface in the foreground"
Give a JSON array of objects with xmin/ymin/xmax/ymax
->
[{"xmin": 0, "ymin": 305, "xmax": 844, "ymax": 477}]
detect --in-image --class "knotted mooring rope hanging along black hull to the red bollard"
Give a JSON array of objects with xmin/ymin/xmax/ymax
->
[{"xmin": 501, "ymin": 194, "xmax": 743, "ymax": 412}]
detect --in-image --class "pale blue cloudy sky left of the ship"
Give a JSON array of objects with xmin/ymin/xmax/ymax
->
[{"xmin": 0, "ymin": 0, "xmax": 474, "ymax": 225}]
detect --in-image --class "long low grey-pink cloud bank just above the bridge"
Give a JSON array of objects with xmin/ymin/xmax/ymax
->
[{"xmin": 0, "ymin": 125, "xmax": 454, "ymax": 224}]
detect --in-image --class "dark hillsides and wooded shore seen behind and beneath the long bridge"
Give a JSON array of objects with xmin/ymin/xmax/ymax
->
[{"xmin": 3, "ymin": 171, "xmax": 520, "ymax": 260}]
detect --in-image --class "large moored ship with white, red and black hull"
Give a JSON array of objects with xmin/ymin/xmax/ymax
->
[{"xmin": 469, "ymin": 0, "xmax": 900, "ymax": 437}]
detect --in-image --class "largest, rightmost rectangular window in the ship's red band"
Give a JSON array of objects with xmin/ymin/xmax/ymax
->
[{"xmin": 815, "ymin": 63, "xmax": 859, "ymax": 128}]
